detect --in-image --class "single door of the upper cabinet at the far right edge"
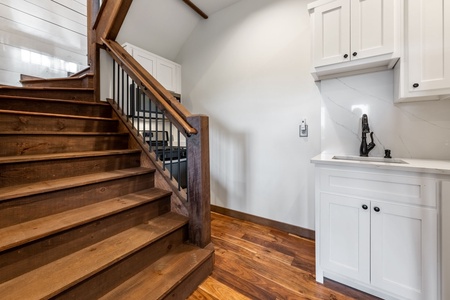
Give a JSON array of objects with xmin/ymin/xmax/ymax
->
[{"xmin": 407, "ymin": 0, "xmax": 450, "ymax": 92}]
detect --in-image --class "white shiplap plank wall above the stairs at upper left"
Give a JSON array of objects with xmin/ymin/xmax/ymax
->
[{"xmin": 0, "ymin": 0, "xmax": 87, "ymax": 85}]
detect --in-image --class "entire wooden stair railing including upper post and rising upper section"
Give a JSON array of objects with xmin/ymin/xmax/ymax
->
[{"xmin": 88, "ymin": 0, "xmax": 211, "ymax": 247}]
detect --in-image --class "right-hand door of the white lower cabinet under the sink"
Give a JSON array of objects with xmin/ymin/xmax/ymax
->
[{"xmin": 371, "ymin": 202, "xmax": 437, "ymax": 300}]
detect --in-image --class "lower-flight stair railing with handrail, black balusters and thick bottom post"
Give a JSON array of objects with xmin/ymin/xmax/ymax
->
[{"xmin": 103, "ymin": 40, "xmax": 211, "ymax": 247}]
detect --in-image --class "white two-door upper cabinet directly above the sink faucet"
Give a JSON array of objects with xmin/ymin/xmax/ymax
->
[{"xmin": 308, "ymin": 0, "xmax": 401, "ymax": 80}]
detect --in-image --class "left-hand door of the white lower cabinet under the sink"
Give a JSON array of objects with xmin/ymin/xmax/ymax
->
[{"xmin": 320, "ymin": 193, "xmax": 370, "ymax": 283}]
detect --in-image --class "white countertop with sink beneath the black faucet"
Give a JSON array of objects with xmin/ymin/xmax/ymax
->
[{"xmin": 311, "ymin": 154, "xmax": 450, "ymax": 175}]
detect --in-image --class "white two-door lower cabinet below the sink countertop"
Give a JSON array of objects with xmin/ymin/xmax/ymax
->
[{"xmin": 316, "ymin": 167, "xmax": 439, "ymax": 300}]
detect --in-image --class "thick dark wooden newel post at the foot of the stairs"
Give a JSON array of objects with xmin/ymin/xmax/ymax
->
[{"xmin": 186, "ymin": 115, "xmax": 211, "ymax": 248}]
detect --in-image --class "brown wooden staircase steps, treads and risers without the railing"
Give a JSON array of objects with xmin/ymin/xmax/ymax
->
[{"xmin": 0, "ymin": 78, "xmax": 214, "ymax": 300}]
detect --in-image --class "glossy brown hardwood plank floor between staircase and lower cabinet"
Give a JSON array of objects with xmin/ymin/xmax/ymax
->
[{"xmin": 188, "ymin": 213, "xmax": 379, "ymax": 300}]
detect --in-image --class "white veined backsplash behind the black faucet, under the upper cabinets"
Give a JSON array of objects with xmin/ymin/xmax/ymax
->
[{"xmin": 321, "ymin": 71, "xmax": 450, "ymax": 160}]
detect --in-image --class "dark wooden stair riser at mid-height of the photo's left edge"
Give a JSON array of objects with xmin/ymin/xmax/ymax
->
[{"xmin": 0, "ymin": 134, "xmax": 128, "ymax": 156}]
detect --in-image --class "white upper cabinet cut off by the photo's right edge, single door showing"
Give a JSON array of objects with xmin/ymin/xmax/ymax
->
[{"xmin": 396, "ymin": 0, "xmax": 450, "ymax": 102}]
